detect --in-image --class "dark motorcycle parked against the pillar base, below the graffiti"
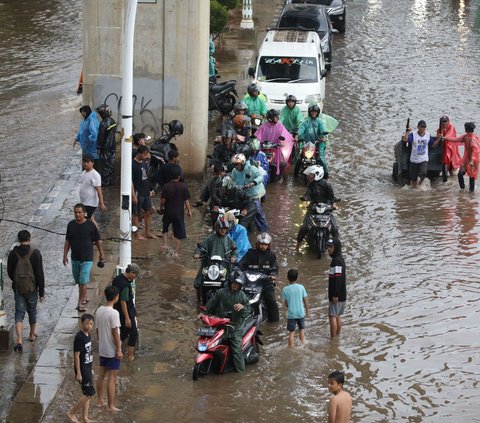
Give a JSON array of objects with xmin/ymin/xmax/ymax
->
[{"xmin": 148, "ymin": 121, "xmax": 183, "ymax": 190}]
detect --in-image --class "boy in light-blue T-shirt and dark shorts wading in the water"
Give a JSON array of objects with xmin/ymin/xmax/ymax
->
[{"xmin": 282, "ymin": 269, "xmax": 310, "ymax": 348}]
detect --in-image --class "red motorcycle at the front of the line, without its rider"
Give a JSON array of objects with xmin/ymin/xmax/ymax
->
[{"xmin": 192, "ymin": 314, "xmax": 262, "ymax": 380}]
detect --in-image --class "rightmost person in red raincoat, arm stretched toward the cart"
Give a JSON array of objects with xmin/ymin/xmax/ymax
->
[{"xmin": 445, "ymin": 122, "xmax": 480, "ymax": 192}]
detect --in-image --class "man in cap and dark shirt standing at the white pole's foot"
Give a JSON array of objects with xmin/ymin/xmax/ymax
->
[{"xmin": 112, "ymin": 263, "xmax": 140, "ymax": 361}]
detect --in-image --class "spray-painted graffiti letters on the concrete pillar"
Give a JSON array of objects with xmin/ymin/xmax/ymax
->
[{"xmin": 103, "ymin": 92, "xmax": 162, "ymax": 139}]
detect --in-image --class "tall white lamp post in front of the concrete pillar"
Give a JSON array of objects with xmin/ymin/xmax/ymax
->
[{"xmin": 119, "ymin": 0, "xmax": 137, "ymax": 272}]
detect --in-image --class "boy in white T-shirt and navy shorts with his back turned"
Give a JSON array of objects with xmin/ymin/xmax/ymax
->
[{"xmin": 96, "ymin": 285, "xmax": 123, "ymax": 412}]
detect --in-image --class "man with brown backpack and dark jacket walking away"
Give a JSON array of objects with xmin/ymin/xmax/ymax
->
[{"xmin": 7, "ymin": 230, "xmax": 45, "ymax": 352}]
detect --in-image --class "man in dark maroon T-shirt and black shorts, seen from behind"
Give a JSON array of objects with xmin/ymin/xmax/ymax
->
[{"xmin": 160, "ymin": 166, "xmax": 192, "ymax": 257}]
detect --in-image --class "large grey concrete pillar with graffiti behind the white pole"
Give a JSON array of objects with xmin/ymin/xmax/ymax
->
[{"xmin": 83, "ymin": 0, "xmax": 210, "ymax": 174}]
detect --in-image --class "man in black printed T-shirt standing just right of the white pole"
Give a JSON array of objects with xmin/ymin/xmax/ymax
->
[{"xmin": 132, "ymin": 145, "xmax": 154, "ymax": 239}]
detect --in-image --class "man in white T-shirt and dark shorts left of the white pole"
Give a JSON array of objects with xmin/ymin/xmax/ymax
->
[{"xmin": 79, "ymin": 154, "xmax": 107, "ymax": 226}]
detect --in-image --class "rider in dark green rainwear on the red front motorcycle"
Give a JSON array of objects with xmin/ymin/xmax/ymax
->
[{"xmin": 197, "ymin": 269, "xmax": 250, "ymax": 373}]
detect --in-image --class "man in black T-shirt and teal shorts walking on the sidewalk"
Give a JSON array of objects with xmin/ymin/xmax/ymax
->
[{"xmin": 63, "ymin": 203, "xmax": 105, "ymax": 313}]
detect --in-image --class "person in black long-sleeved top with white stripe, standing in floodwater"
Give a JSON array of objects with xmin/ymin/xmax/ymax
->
[{"xmin": 327, "ymin": 238, "xmax": 347, "ymax": 338}]
